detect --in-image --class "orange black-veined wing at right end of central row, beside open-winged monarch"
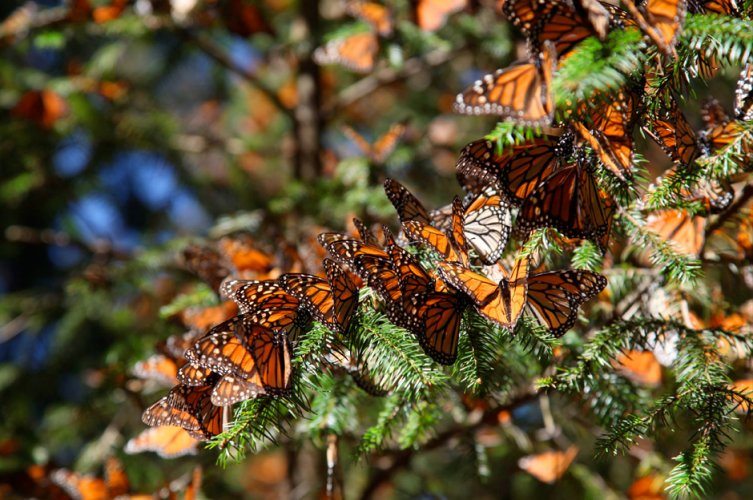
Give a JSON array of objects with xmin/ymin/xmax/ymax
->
[{"xmin": 528, "ymin": 269, "xmax": 607, "ymax": 337}]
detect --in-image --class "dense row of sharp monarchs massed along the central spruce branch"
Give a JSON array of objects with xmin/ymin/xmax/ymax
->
[{"xmin": 134, "ymin": 166, "xmax": 606, "ymax": 449}]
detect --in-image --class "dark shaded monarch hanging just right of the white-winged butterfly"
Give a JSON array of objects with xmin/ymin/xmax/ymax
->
[{"xmin": 518, "ymin": 161, "xmax": 614, "ymax": 252}]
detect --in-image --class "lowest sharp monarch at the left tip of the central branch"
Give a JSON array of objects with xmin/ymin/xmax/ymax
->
[{"xmin": 141, "ymin": 376, "xmax": 222, "ymax": 441}]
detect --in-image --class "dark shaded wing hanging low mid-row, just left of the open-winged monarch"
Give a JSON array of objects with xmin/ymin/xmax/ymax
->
[{"xmin": 417, "ymin": 293, "xmax": 467, "ymax": 365}]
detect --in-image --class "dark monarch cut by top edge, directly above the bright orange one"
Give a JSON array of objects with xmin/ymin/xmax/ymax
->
[{"xmin": 498, "ymin": 0, "xmax": 610, "ymax": 56}]
